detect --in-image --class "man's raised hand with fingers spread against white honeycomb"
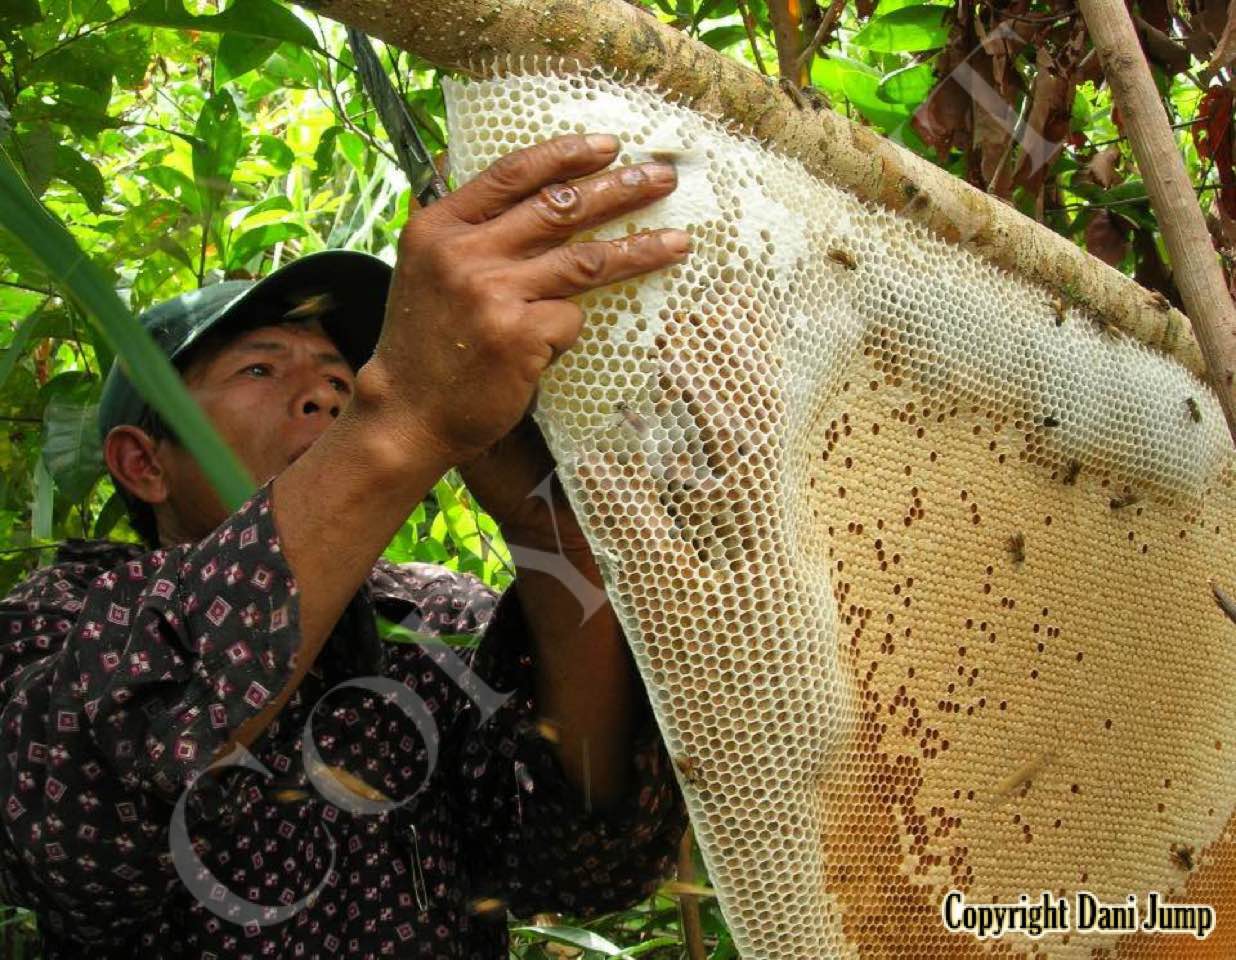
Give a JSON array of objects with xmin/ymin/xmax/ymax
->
[{"xmin": 357, "ymin": 135, "xmax": 688, "ymax": 465}]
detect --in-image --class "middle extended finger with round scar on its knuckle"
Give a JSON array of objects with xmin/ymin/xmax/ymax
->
[{"xmin": 482, "ymin": 163, "xmax": 677, "ymax": 257}]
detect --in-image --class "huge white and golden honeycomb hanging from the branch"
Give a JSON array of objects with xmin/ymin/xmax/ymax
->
[{"xmin": 445, "ymin": 62, "xmax": 1236, "ymax": 960}]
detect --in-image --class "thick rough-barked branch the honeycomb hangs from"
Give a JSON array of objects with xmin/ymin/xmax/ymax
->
[{"xmin": 299, "ymin": 0, "xmax": 1205, "ymax": 392}]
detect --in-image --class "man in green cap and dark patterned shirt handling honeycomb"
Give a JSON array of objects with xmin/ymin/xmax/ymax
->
[{"xmin": 0, "ymin": 136, "xmax": 687, "ymax": 960}]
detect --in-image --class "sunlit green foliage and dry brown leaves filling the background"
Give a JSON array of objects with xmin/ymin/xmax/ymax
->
[{"xmin": 0, "ymin": 0, "xmax": 1236, "ymax": 960}]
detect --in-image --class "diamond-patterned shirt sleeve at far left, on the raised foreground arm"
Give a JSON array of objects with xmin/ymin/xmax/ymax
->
[{"xmin": 0, "ymin": 484, "xmax": 299, "ymax": 940}]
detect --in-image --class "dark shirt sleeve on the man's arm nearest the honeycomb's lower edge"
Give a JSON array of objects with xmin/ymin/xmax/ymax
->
[{"xmin": 435, "ymin": 573, "xmax": 686, "ymax": 918}]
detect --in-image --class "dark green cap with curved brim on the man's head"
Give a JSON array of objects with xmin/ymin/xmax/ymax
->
[{"xmin": 99, "ymin": 250, "xmax": 392, "ymax": 439}]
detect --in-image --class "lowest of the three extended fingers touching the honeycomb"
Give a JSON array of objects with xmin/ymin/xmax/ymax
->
[{"xmin": 515, "ymin": 230, "xmax": 691, "ymax": 300}]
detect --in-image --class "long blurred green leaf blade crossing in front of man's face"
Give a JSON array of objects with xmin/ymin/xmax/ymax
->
[{"xmin": 0, "ymin": 141, "xmax": 253, "ymax": 509}]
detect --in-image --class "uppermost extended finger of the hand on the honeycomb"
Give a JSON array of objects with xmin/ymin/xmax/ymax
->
[{"xmin": 439, "ymin": 133, "xmax": 618, "ymax": 224}]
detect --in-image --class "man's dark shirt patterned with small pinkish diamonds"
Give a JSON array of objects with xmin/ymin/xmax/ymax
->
[{"xmin": 0, "ymin": 486, "xmax": 685, "ymax": 960}]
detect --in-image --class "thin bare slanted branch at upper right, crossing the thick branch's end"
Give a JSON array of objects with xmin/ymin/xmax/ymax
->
[{"xmin": 1078, "ymin": 0, "xmax": 1236, "ymax": 440}]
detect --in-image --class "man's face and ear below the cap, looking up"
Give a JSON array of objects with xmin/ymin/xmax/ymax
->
[{"xmin": 146, "ymin": 322, "xmax": 355, "ymax": 541}]
